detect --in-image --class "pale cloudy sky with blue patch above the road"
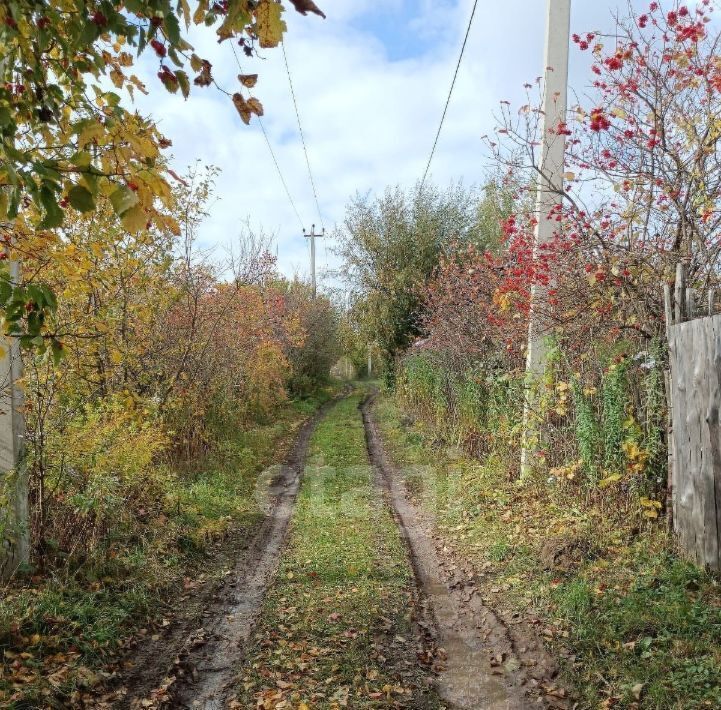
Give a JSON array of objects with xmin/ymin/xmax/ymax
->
[{"xmin": 132, "ymin": 0, "xmax": 646, "ymax": 286}]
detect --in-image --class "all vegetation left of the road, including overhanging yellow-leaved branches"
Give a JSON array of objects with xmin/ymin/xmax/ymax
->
[{"xmin": 0, "ymin": 0, "xmax": 338, "ymax": 707}]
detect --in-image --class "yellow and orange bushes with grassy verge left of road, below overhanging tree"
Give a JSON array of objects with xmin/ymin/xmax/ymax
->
[{"xmin": 0, "ymin": 165, "xmax": 338, "ymax": 706}]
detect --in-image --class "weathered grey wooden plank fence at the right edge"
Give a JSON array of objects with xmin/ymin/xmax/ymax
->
[{"xmin": 664, "ymin": 266, "xmax": 721, "ymax": 572}]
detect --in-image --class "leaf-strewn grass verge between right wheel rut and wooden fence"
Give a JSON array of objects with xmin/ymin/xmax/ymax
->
[{"xmin": 376, "ymin": 396, "xmax": 721, "ymax": 710}]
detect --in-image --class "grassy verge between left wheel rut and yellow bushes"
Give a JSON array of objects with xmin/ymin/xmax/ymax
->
[{"xmin": 0, "ymin": 394, "xmax": 329, "ymax": 708}]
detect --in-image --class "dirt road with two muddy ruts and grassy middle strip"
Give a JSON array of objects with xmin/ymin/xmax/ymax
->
[{"xmin": 116, "ymin": 394, "xmax": 566, "ymax": 710}]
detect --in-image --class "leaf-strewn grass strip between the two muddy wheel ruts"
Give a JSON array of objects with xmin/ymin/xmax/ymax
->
[{"xmin": 239, "ymin": 395, "xmax": 439, "ymax": 708}]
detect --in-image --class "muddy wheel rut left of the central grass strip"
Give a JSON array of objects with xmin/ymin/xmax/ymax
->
[{"xmin": 113, "ymin": 398, "xmax": 338, "ymax": 710}]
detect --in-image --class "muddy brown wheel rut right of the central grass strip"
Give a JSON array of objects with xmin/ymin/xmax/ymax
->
[{"xmin": 361, "ymin": 395, "xmax": 568, "ymax": 710}]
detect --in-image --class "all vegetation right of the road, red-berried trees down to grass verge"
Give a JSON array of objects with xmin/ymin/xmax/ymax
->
[{"xmin": 343, "ymin": 2, "xmax": 721, "ymax": 709}]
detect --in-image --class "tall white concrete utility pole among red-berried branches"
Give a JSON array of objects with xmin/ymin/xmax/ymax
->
[{"xmin": 521, "ymin": 0, "xmax": 571, "ymax": 477}]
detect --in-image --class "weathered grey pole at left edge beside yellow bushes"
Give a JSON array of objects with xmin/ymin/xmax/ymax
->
[{"xmin": 0, "ymin": 261, "xmax": 30, "ymax": 579}]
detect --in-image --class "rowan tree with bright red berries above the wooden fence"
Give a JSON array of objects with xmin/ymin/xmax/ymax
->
[{"xmin": 491, "ymin": 0, "xmax": 721, "ymax": 340}]
